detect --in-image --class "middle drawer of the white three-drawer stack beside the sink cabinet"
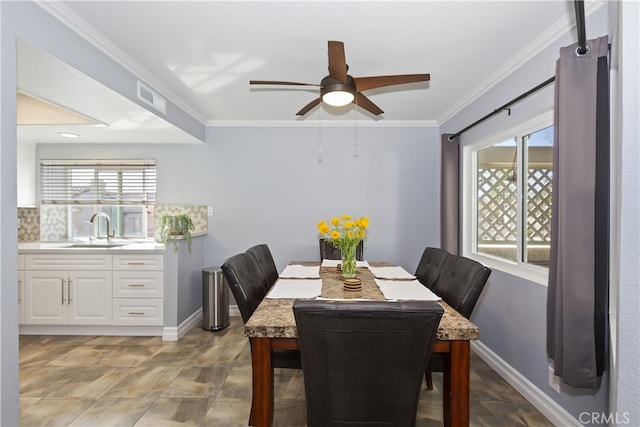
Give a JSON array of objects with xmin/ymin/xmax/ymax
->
[{"xmin": 113, "ymin": 270, "xmax": 164, "ymax": 298}]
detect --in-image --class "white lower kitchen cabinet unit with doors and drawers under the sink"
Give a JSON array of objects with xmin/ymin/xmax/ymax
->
[{"xmin": 18, "ymin": 250, "xmax": 165, "ymax": 334}]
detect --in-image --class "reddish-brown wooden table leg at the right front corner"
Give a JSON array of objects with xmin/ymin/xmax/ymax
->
[{"xmin": 442, "ymin": 340, "xmax": 471, "ymax": 427}]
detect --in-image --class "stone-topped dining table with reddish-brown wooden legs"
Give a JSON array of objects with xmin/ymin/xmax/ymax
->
[{"xmin": 245, "ymin": 261, "xmax": 479, "ymax": 427}]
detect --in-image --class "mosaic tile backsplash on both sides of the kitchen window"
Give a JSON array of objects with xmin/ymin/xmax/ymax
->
[{"xmin": 18, "ymin": 205, "xmax": 209, "ymax": 242}]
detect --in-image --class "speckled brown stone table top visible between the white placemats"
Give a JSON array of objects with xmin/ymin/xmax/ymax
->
[{"xmin": 245, "ymin": 263, "xmax": 479, "ymax": 341}]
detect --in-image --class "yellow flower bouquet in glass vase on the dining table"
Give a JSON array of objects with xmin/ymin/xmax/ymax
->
[{"xmin": 318, "ymin": 215, "xmax": 369, "ymax": 278}]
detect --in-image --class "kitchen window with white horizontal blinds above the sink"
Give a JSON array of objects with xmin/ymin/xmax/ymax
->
[{"xmin": 40, "ymin": 160, "xmax": 156, "ymax": 239}]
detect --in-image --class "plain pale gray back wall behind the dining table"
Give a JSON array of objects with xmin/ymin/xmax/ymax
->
[{"xmin": 203, "ymin": 125, "xmax": 439, "ymax": 270}]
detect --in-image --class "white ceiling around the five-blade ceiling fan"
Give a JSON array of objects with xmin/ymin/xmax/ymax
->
[{"xmin": 19, "ymin": 0, "xmax": 574, "ymax": 142}]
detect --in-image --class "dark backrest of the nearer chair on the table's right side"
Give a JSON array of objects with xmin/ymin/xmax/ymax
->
[{"xmin": 432, "ymin": 254, "xmax": 491, "ymax": 319}]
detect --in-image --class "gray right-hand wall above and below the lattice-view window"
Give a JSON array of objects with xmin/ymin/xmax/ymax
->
[{"xmin": 442, "ymin": 7, "xmax": 620, "ymax": 422}]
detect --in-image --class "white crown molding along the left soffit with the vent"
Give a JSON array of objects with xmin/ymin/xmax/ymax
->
[{"xmin": 35, "ymin": 0, "xmax": 207, "ymax": 124}]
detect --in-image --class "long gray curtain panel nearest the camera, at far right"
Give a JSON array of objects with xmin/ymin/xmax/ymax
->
[{"xmin": 547, "ymin": 36, "xmax": 609, "ymax": 389}]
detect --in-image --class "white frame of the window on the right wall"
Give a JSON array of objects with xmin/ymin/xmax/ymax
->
[{"xmin": 462, "ymin": 111, "xmax": 554, "ymax": 286}]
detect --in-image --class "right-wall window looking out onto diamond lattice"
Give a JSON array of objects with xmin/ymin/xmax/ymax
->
[{"xmin": 464, "ymin": 117, "xmax": 553, "ymax": 280}]
